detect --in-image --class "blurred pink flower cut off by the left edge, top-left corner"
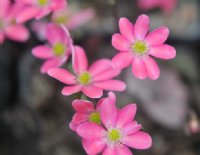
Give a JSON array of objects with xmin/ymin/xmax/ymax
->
[{"xmin": 0, "ymin": 0, "xmax": 29, "ymax": 44}]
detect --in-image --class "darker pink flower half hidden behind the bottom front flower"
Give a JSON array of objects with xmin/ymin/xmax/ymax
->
[{"xmin": 70, "ymin": 96, "xmax": 116, "ymax": 131}]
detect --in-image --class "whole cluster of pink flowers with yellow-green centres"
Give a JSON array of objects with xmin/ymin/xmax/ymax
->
[{"xmin": 0, "ymin": 0, "xmax": 176, "ymax": 155}]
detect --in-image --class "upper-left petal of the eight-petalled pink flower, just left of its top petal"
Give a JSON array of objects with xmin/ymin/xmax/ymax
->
[{"xmin": 119, "ymin": 17, "xmax": 135, "ymax": 43}]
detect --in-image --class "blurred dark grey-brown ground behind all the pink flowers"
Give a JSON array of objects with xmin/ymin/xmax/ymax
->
[{"xmin": 0, "ymin": 0, "xmax": 200, "ymax": 155}]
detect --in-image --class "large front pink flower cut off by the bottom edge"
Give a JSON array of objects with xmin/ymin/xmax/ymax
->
[{"xmin": 76, "ymin": 92, "xmax": 152, "ymax": 155}]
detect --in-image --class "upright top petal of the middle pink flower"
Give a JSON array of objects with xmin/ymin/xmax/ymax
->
[{"xmin": 72, "ymin": 46, "xmax": 88, "ymax": 74}]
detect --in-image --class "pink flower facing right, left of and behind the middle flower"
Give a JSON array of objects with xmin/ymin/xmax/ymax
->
[{"xmin": 32, "ymin": 24, "xmax": 73, "ymax": 73}]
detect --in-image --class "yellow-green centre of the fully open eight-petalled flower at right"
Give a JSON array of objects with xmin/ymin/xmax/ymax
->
[{"xmin": 131, "ymin": 41, "xmax": 148, "ymax": 54}]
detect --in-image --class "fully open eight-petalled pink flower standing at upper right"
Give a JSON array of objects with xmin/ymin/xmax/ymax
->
[{"xmin": 112, "ymin": 15, "xmax": 176, "ymax": 80}]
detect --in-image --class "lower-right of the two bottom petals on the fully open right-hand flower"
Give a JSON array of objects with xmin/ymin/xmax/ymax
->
[{"xmin": 143, "ymin": 56, "xmax": 160, "ymax": 80}]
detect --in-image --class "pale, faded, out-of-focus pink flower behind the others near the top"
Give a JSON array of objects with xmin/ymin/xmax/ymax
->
[{"xmin": 52, "ymin": 7, "xmax": 95, "ymax": 30}]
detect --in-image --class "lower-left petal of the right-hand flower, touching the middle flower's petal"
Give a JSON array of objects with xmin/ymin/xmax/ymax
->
[{"xmin": 112, "ymin": 52, "xmax": 133, "ymax": 69}]
